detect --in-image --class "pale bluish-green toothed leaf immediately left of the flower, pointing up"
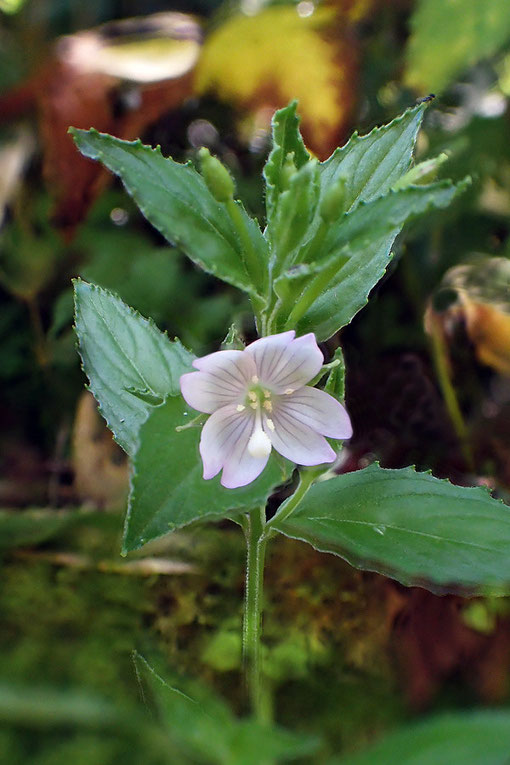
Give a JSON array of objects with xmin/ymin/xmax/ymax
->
[{"xmin": 74, "ymin": 279, "xmax": 193, "ymax": 457}]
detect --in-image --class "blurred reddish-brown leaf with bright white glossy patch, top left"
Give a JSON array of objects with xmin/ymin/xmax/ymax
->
[{"xmin": 0, "ymin": 12, "xmax": 201, "ymax": 239}]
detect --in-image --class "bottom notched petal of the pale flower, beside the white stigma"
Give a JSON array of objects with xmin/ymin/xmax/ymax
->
[{"xmin": 200, "ymin": 405, "xmax": 269, "ymax": 489}]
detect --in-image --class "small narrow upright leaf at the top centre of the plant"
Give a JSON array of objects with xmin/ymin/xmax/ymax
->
[{"xmin": 264, "ymin": 101, "xmax": 310, "ymax": 227}]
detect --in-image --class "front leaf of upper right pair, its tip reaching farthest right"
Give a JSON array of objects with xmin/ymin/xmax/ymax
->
[{"xmin": 276, "ymin": 181, "xmax": 467, "ymax": 340}]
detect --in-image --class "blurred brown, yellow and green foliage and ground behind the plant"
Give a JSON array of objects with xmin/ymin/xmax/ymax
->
[{"xmin": 0, "ymin": 0, "xmax": 510, "ymax": 765}]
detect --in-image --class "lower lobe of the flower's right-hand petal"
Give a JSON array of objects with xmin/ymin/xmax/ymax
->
[{"xmin": 264, "ymin": 407, "xmax": 336, "ymax": 465}]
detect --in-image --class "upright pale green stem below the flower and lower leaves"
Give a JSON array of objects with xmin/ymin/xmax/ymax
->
[{"xmin": 243, "ymin": 507, "xmax": 266, "ymax": 718}]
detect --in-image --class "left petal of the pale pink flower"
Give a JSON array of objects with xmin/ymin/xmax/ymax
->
[{"xmin": 180, "ymin": 351, "xmax": 256, "ymax": 414}]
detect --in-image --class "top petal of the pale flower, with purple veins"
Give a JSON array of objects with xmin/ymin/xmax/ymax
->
[{"xmin": 245, "ymin": 332, "xmax": 324, "ymax": 393}]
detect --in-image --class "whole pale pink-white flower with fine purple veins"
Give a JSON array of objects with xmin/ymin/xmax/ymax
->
[{"xmin": 180, "ymin": 330, "xmax": 352, "ymax": 489}]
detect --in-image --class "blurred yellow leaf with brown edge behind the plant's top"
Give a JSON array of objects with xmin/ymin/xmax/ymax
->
[{"xmin": 196, "ymin": 3, "xmax": 358, "ymax": 156}]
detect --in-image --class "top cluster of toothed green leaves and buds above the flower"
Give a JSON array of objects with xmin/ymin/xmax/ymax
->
[{"xmin": 71, "ymin": 98, "xmax": 465, "ymax": 342}]
